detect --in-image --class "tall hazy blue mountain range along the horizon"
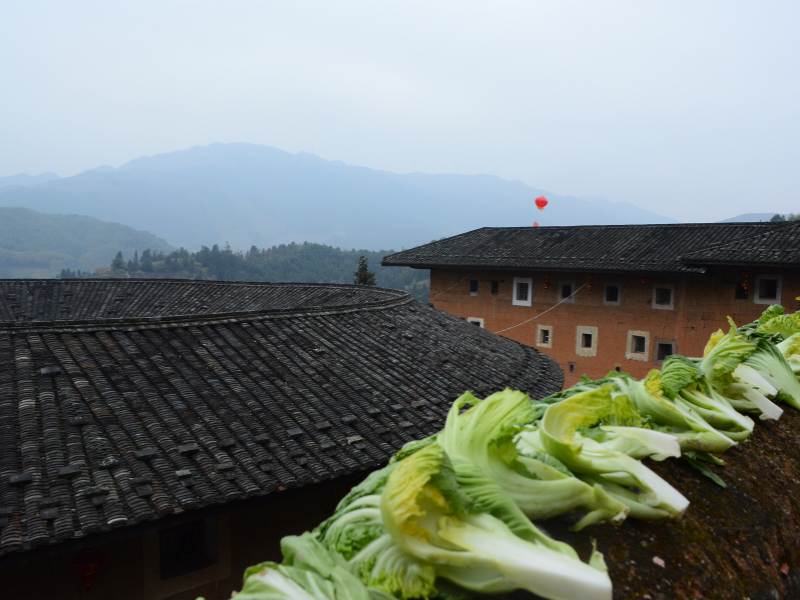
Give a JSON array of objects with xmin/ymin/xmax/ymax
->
[{"xmin": 0, "ymin": 144, "xmax": 670, "ymax": 250}]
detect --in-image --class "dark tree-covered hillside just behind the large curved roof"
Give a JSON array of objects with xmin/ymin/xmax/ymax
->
[{"xmin": 62, "ymin": 242, "xmax": 428, "ymax": 300}]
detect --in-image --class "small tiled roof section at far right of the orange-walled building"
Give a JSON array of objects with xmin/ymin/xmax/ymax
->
[{"xmin": 684, "ymin": 221, "xmax": 800, "ymax": 268}]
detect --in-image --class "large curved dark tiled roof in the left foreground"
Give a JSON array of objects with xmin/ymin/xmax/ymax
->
[{"xmin": 0, "ymin": 280, "xmax": 562, "ymax": 555}]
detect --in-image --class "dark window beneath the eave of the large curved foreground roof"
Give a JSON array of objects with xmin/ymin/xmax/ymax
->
[{"xmin": 158, "ymin": 519, "xmax": 217, "ymax": 579}]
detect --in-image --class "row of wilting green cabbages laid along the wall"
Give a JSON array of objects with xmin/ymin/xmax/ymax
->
[{"xmin": 227, "ymin": 306, "xmax": 800, "ymax": 600}]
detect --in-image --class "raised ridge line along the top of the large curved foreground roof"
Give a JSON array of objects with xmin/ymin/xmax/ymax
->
[{"xmin": 0, "ymin": 293, "xmax": 415, "ymax": 333}]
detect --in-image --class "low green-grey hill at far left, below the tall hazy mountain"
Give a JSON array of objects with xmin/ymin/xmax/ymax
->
[{"xmin": 0, "ymin": 208, "xmax": 171, "ymax": 277}]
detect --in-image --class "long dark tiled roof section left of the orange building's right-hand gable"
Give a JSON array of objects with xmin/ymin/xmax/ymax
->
[{"xmin": 383, "ymin": 223, "xmax": 788, "ymax": 273}]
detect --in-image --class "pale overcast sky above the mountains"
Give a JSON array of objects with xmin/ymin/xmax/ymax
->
[{"xmin": 0, "ymin": 0, "xmax": 800, "ymax": 221}]
